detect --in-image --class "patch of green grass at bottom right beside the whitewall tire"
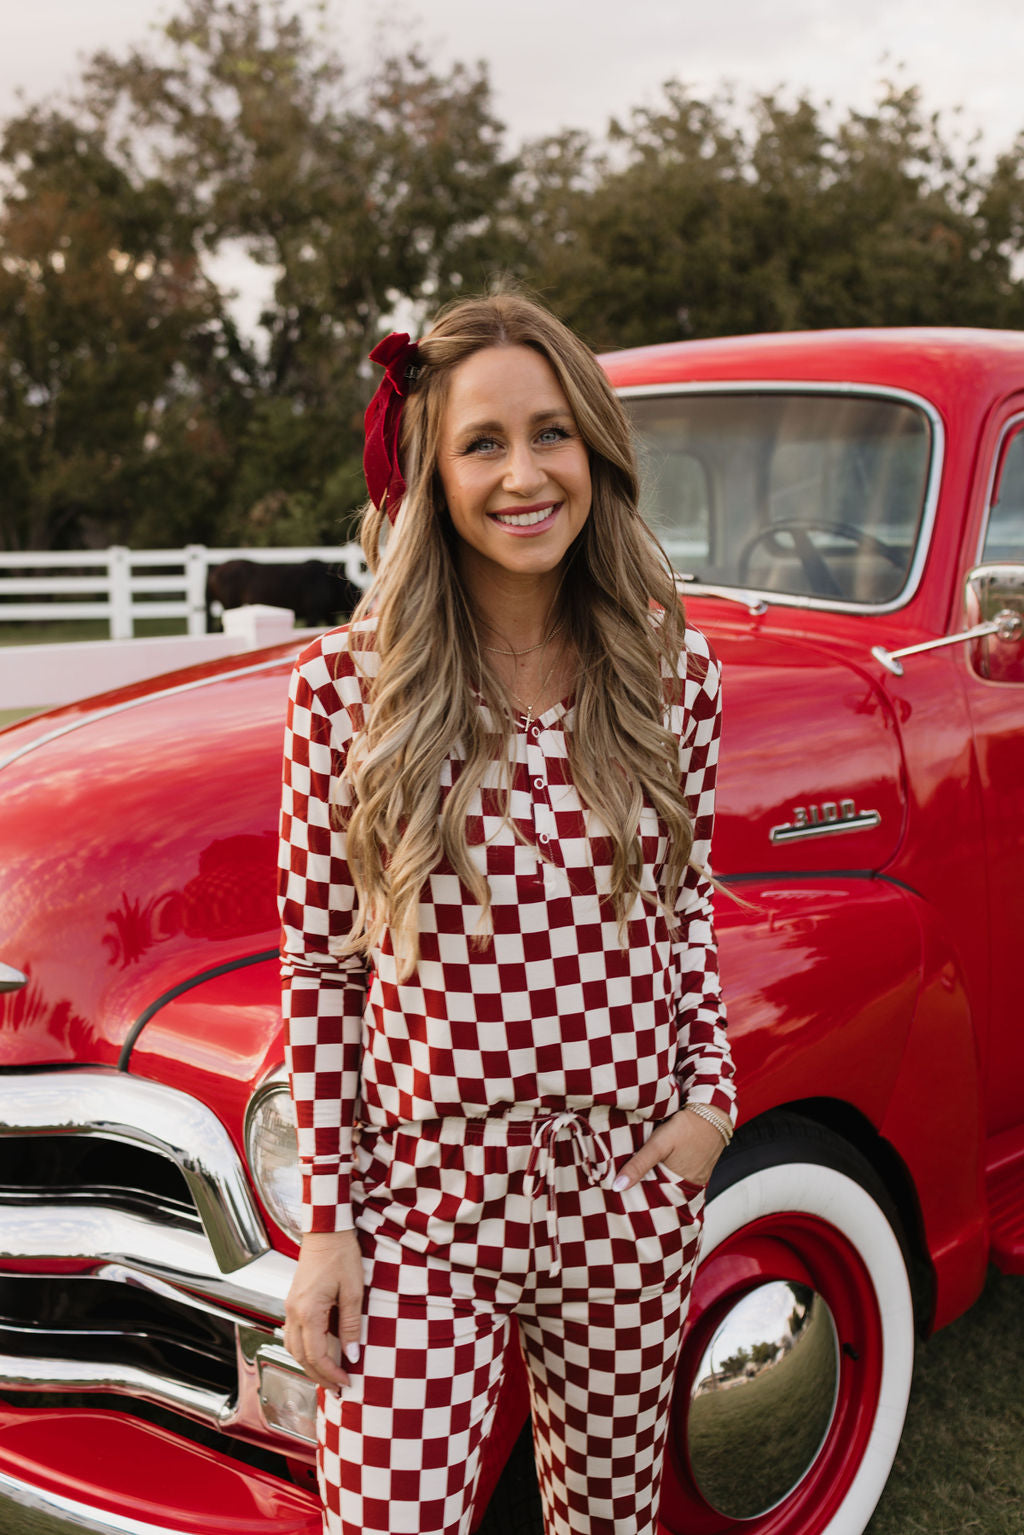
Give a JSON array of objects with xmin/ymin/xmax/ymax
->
[{"xmin": 867, "ymin": 1269, "xmax": 1024, "ymax": 1535}]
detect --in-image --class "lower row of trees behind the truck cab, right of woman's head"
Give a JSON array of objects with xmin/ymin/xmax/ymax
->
[{"xmin": 517, "ymin": 83, "xmax": 1024, "ymax": 347}]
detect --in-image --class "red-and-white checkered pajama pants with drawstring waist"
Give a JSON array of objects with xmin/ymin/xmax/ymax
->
[{"xmin": 319, "ymin": 1108, "xmax": 703, "ymax": 1535}]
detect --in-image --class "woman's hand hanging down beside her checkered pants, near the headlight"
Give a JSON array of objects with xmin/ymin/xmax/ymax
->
[{"xmin": 284, "ymin": 1231, "xmax": 362, "ymax": 1391}]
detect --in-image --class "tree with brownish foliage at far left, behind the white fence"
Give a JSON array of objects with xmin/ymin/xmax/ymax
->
[{"xmin": 0, "ymin": 109, "xmax": 244, "ymax": 550}]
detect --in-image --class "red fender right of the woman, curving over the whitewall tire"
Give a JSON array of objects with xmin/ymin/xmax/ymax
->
[{"xmin": 717, "ymin": 875, "xmax": 986, "ymax": 1326}]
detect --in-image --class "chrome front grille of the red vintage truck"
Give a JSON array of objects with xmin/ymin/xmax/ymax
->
[{"xmin": 0, "ymin": 1068, "xmax": 312, "ymax": 1455}]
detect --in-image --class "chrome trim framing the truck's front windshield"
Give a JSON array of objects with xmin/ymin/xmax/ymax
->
[{"xmin": 617, "ymin": 379, "xmax": 946, "ymax": 614}]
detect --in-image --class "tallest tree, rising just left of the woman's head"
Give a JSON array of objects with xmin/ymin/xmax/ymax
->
[{"xmin": 78, "ymin": 0, "xmax": 514, "ymax": 542}]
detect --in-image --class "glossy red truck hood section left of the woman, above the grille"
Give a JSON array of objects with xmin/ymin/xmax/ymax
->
[{"xmin": 0, "ymin": 646, "xmax": 295, "ymax": 1067}]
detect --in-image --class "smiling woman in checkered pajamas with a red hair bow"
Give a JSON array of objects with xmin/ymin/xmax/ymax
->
[{"xmin": 281, "ymin": 295, "xmax": 734, "ymax": 1535}]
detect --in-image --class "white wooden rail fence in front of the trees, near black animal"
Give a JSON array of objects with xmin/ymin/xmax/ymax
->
[{"xmin": 0, "ymin": 543, "xmax": 367, "ymax": 640}]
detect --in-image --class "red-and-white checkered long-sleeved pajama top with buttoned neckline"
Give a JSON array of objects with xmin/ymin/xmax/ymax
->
[{"xmin": 279, "ymin": 619, "xmax": 734, "ymax": 1231}]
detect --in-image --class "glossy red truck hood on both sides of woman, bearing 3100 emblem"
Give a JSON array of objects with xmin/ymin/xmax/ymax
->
[{"xmin": 0, "ymin": 629, "xmax": 903, "ymax": 1067}]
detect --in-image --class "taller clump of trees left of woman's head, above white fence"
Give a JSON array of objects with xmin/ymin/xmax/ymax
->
[{"xmin": 0, "ymin": 0, "xmax": 513, "ymax": 548}]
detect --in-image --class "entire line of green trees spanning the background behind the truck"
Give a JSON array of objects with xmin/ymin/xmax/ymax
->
[{"xmin": 0, "ymin": 0, "xmax": 1024, "ymax": 548}]
